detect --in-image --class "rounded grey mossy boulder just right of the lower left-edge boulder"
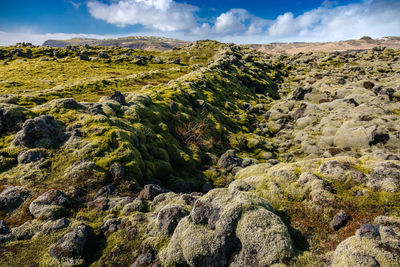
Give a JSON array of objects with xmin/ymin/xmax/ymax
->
[{"xmin": 29, "ymin": 189, "xmax": 70, "ymax": 219}]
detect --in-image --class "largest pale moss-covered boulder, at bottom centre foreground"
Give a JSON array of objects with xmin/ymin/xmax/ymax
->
[{"xmin": 159, "ymin": 189, "xmax": 293, "ymax": 266}]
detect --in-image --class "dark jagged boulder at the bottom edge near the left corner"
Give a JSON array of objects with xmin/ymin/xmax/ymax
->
[{"xmin": 50, "ymin": 224, "xmax": 89, "ymax": 266}]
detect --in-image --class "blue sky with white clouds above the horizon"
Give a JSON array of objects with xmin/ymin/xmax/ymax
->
[{"xmin": 0, "ymin": 0, "xmax": 400, "ymax": 45}]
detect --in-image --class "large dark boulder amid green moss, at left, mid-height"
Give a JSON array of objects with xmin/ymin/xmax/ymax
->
[{"xmin": 13, "ymin": 115, "xmax": 67, "ymax": 148}]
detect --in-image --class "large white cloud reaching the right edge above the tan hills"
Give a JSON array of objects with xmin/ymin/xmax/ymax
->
[{"xmin": 268, "ymin": 0, "xmax": 400, "ymax": 41}]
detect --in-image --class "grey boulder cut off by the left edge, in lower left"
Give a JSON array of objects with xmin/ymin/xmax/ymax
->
[{"xmin": 0, "ymin": 185, "xmax": 30, "ymax": 212}]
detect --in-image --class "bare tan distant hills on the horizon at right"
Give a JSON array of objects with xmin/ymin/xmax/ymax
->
[{"xmin": 245, "ymin": 36, "xmax": 400, "ymax": 54}]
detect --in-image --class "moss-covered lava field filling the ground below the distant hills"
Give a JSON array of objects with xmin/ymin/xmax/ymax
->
[{"xmin": 0, "ymin": 41, "xmax": 400, "ymax": 266}]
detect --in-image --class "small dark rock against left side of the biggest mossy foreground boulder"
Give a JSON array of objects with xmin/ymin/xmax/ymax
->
[{"xmin": 157, "ymin": 205, "xmax": 189, "ymax": 235}]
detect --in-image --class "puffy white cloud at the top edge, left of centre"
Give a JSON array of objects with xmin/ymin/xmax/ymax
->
[{"xmin": 87, "ymin": 0, "xmax": 198, "ymax": 32}]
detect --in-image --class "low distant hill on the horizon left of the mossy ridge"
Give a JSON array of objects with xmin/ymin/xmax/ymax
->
[{"xmin": 43, "ymin": 36, "xmax": 189, "ymax": 51}]
